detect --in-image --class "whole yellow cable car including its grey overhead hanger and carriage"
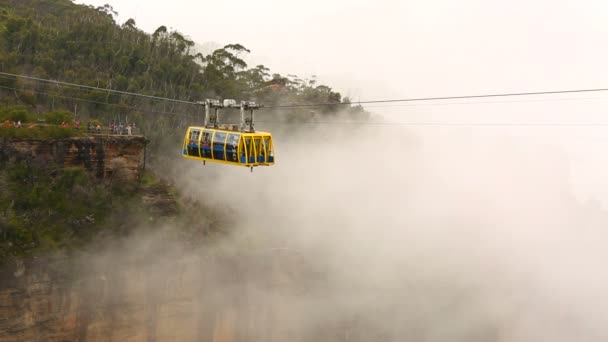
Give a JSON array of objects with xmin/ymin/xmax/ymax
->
[{"xmin": 182, "ymin": 100, "xmax": 274, "ymax": 171}]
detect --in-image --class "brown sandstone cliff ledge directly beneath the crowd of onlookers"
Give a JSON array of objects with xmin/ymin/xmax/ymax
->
[{"xmin": 0, "ymin": 136, "xmax": 147, "ymax": 181}]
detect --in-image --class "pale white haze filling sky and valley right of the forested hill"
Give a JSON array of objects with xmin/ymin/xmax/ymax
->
[{"xmin": 61, "ymin": 0, "xmax": 608, "ymax": 341}]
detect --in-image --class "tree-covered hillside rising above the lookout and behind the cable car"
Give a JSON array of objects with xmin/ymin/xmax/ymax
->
[{"xmin": 0, "ymin": 0, "xmax": 365, "ymax": 129}]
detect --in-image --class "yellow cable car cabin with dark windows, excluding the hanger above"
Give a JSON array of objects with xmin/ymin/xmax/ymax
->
[{"xmin": 182, "ymin": 127, "xmax": 274, "ymax": 167}]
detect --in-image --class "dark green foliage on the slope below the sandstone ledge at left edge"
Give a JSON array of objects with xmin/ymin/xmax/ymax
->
[{"xmin": 0, "ymin": 162, "xmax": 140, "ymax": 263}]
